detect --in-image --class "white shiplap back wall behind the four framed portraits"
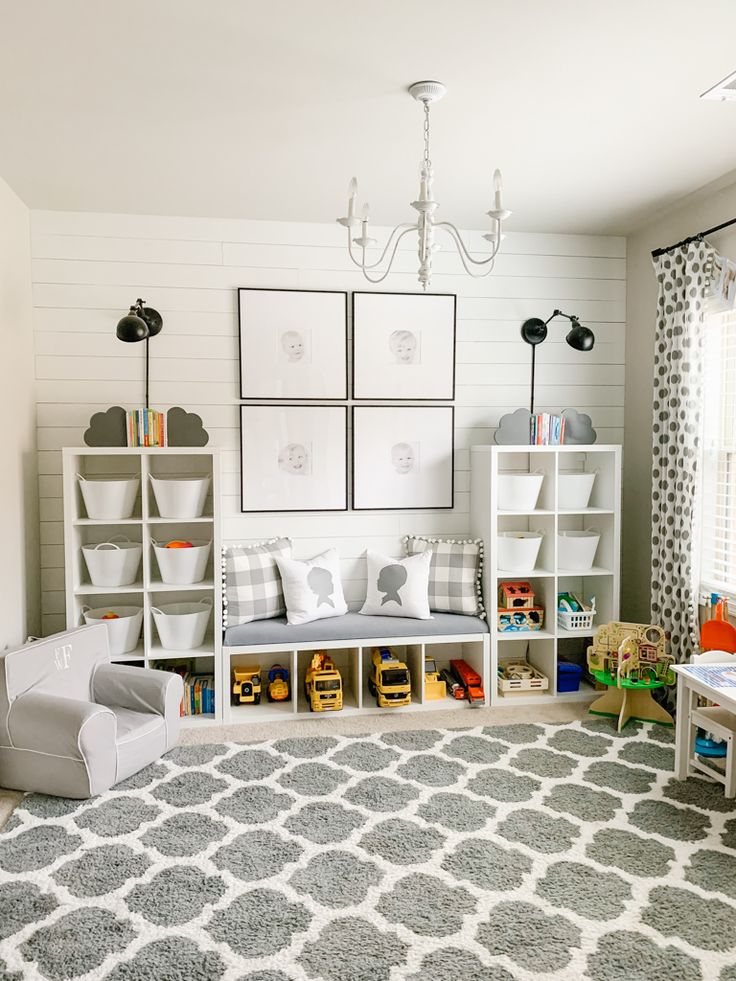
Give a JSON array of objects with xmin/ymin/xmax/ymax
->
[{"xmin": 32, "ymin": 212, "xmax": 626, "ymax": 633}]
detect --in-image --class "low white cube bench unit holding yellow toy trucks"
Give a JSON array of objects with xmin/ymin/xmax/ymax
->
[{"xmin": 223, "ymin": 633, "xmax": 490, "ymax": 725}]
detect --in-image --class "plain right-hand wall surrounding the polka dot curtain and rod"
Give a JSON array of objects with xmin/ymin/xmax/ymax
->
[{"xmin": 621, "ymin": 171, "xmax": 736, "ymax": 622}]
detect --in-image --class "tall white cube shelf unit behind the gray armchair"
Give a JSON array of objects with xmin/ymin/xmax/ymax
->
[{"xmin": 63, "ymin": 446, "xmax": 227, "ymax": 725}]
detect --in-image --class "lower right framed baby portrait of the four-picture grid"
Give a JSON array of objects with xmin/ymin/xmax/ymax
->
[{"xmin": 353, "ymin": 405, "xmax": 455, "ymax": 511}]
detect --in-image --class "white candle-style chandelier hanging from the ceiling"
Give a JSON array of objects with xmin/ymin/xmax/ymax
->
[{"xmin": 337, "ymin": 82, "xmax": 511, "ymax": 290}]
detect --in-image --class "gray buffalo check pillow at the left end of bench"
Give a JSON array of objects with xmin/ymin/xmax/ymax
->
[{"xmin": 222, "ymin": 538, "xmax": 291, "ymax": 627}]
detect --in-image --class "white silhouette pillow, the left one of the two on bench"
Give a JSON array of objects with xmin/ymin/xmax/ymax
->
[{"xmin": 275, "ymin": 548, "xmax": 348, "ymax": 624}]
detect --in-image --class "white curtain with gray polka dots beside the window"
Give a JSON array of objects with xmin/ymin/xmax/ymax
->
[{"xmin": 651, "ymin": 241, "xmax": 714, "ymax": 662}]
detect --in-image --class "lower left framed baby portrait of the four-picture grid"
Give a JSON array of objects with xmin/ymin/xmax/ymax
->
[{"xmin": 240, "ymin": 405, "xmax": 348, "ymax": 512}]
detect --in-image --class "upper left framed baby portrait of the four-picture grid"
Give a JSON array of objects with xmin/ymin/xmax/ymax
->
[{"xmin": 238, "ymin": 288, "xmax": 348, "ymax": 401}]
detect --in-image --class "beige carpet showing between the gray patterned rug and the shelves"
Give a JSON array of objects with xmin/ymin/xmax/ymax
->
[{"xmin": 0, "ymin": 702, "xmax": 588, "ymax": 829}]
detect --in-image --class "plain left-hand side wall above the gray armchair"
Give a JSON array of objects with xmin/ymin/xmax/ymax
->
[{"xmin": 0, "ymin": 179, "xmax": 40, "ymax": 650}]
